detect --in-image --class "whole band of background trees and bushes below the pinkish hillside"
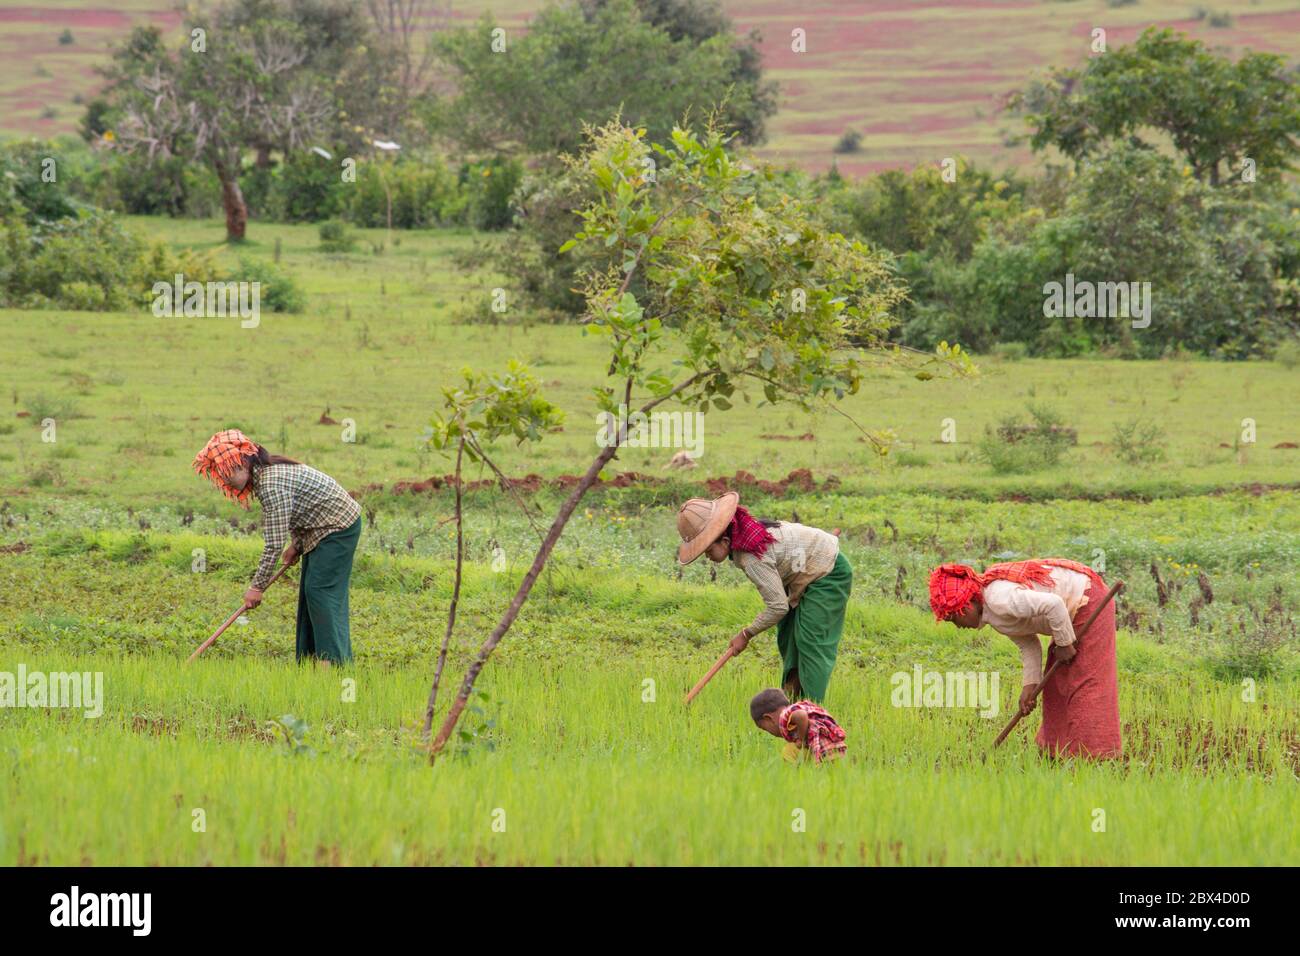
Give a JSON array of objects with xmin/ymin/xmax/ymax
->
[{"xmin": 8, "ymin": 8, "xmax": 1300, "ymax": 359}]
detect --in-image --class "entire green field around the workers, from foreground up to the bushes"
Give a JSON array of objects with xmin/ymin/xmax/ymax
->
[{"xmin": 0, "ymin": 220, "xmax": 1300, "ymax": 865}]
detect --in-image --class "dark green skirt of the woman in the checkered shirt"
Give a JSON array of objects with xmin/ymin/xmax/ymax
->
[{"xmin": 298, "ymin": 518, "xmax": 361, "ymax": 663}]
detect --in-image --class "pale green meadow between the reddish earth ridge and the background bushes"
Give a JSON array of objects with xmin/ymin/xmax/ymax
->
[{"xmin": 0, "ymin": 220, "xmax": 1300, "ymax": 506}]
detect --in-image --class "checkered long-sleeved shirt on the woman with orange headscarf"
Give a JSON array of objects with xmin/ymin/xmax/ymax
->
[{"xmin": 252, "ymin": 464, "xmax": 361, "ymax": 589}]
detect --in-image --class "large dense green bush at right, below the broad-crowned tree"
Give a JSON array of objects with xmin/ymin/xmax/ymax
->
[{"xmin": 898, "ymin": 144, "xmax": 1300, "ymax": 359}]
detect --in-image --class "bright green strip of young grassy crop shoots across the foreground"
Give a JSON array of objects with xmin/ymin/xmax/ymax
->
[{"xmin": 0, "ymin": 654, "xmax": 1300, "ymax": 865}]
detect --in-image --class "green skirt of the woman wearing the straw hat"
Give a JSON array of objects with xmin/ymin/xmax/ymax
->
[{"xmin": 776, "ymin": 553, "xmax": 853, "ymax": 704}]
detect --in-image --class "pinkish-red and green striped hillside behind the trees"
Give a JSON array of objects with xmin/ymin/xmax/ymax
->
[{"xmin": 0, "ymin": 0, "xmax": 1300, "ymax": 174}]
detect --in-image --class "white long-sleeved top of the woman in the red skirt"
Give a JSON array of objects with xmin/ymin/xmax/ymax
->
[{"xmin": 980, "ymin": 567, "xmax": 1092, "ymax": 685}]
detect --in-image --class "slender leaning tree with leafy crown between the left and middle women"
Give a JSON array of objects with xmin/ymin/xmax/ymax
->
[{"xmin": 430, "ymin": 122, "xmax": 966, "ymax": 760}]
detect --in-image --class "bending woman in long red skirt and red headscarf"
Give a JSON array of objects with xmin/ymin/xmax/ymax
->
[{"xmin": 930, "ymin": 558, "xmax": 1123, "ymax": 758}]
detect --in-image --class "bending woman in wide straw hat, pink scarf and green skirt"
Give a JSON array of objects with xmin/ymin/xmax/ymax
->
[{"xmin": 677, "ymin": 492, "xmax": 853, "ymax": 701}]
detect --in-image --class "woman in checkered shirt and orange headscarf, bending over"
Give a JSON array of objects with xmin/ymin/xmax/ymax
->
[{"xmin": 194, "ymin": 428, "xmax": 361, "ymax": 663}]
